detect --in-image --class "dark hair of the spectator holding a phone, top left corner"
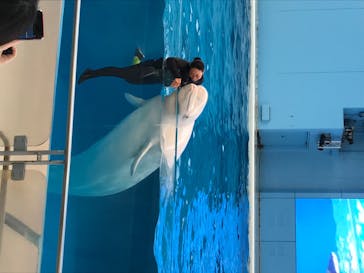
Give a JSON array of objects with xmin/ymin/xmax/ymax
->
[{"xmin": 0, "ymin": 0, "xmax": 38, "ymax": 45}]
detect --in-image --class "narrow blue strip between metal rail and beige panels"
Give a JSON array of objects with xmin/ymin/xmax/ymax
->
[{"xmin": 39, "ymin": 1, "xmax": 74, "ymax": 272}]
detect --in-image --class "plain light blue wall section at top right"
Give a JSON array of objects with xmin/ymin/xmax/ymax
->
[{"xmin": 258, "ymin": 0, "xmax": 364, "ymax": 130}]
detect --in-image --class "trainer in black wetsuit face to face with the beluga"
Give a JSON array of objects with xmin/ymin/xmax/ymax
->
[{"xmin": 78, "ymin": 57, "xmax": 204, "ymax": 87}]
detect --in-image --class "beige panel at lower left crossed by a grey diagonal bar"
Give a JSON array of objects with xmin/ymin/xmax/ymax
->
[{"xmin": 0, "ymin": 170, "xmax": 46, "ymax": 273}]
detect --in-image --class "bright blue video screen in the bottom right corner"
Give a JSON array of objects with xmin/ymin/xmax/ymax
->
[{"xmin": 296, "ymin": 199, "xmax": 364, "ymax": 273}]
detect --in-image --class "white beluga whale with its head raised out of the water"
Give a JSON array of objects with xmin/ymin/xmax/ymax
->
[{"xmin": 69, "ymin": 84, "xmax": 208, "ymax": 196}]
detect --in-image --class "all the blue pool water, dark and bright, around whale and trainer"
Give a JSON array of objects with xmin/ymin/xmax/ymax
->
[{"xmin": 41, "ymin": 0, "xmax": 250, "ymax": 273}]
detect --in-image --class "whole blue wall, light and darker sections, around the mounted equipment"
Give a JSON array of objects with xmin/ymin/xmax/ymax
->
[{"xmin": 258, "ymin": 0, "xmax": 364, "ymax": 192}]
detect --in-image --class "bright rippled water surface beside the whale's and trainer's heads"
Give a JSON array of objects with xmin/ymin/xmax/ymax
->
[{"xmin": 154, "ymin": 0, "xmax": 249, "ymax": 273}]
